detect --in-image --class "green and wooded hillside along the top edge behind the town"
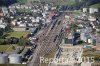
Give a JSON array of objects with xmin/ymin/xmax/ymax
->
[{"xmin": 0, "ymin": 0, "xmax": 100, "ymax": 9}]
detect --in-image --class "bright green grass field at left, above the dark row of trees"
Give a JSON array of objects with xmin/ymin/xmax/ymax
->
[{"xmin": 7, "ymin": 31, "xmax": 28, "ymax": 38}]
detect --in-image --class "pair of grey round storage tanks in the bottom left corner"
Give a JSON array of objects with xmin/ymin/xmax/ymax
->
[{"xmin": 0, "ymin": 53, "xmax": 22, "ymax": 64}]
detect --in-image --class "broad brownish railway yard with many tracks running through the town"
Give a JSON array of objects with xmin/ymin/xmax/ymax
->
[{"xmin": 28, "ymin": 14, "xmax": 63, "ymax": 66}]
